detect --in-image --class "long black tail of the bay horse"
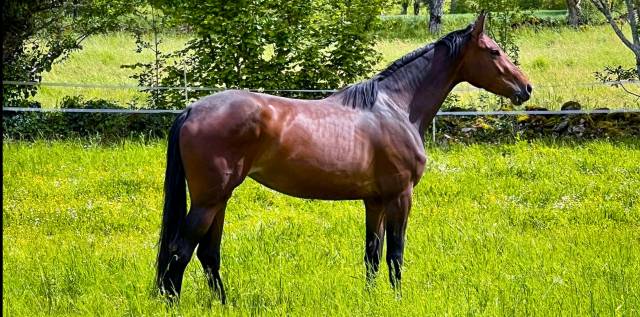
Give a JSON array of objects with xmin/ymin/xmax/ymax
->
[{"xmin": 156, "ymin": 108, "xmax": 191, "ymax": 289}]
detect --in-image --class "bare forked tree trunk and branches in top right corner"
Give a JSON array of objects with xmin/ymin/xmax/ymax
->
[{"xmin": 591, "ymin": 0, "xmax": 640, "ymax": 78}]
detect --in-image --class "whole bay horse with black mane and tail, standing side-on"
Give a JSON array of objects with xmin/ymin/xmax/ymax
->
[{"xmin": 156, "ymin": 13, "xmax": 532, "ymax": 304}]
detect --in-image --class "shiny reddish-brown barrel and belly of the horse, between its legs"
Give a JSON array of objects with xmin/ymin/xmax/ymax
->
[{"xmin": 249, "ymin": 120, "xmax": 377, "ymax": 199}]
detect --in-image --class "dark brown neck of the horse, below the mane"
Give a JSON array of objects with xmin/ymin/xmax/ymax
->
[{"xmin": 380, "ymin": 47, "xmax": 459, "ymax": 136}]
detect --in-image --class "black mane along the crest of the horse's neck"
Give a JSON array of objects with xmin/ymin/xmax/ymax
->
[{"xmin": 331, "ymin": 25, "xmax": 473, "ymax": 109}]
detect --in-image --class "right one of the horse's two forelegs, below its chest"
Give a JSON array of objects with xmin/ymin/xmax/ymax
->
[{"xmin": 385, "ymin": 188, "xmax": 411, "ymax": 291}]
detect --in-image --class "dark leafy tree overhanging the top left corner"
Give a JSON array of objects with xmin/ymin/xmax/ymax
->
[{"xmin": 2, "ymin": 0, "xmax": 137, "ymax": 101}]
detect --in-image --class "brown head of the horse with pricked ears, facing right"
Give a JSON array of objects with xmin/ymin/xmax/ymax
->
[{"xmin": 460, "ymin": 13, "xmax": 533, "ymax": 105}]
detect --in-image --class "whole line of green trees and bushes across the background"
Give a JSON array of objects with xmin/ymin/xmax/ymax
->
[{"xmin": 2, "ymin": 0, "xmax": 640, "ymax": 108}]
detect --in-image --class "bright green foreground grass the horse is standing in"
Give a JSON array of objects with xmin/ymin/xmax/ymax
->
[{"xmin": 2, "ymin": 140, "xmax": 640, "ymax": 316}]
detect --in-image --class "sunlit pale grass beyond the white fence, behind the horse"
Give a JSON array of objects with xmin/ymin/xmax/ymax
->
[{"xmin": 35, "ymin": 25, "xmax": 638, "ymax": 109}]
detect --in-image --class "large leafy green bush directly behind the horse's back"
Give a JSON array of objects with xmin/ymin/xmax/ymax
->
[{"xmin": 125, "ymin": 0, "xmax": 383, "ymax": 108}]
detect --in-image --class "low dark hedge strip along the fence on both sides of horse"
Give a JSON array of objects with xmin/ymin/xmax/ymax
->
[{"xmin": 2, "ymin": 97, "xmax": 640, "ymax": 143}]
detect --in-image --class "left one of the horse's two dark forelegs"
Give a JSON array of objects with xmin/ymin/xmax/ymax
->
[{"xmin": 364, "ymin": 199, "xmax": 384, "ymax": 283}]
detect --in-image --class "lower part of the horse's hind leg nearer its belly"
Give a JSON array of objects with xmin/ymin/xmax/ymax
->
[{"xmin": 197, "ymin": 202, "xmax": 226, "ymax": 305}]
